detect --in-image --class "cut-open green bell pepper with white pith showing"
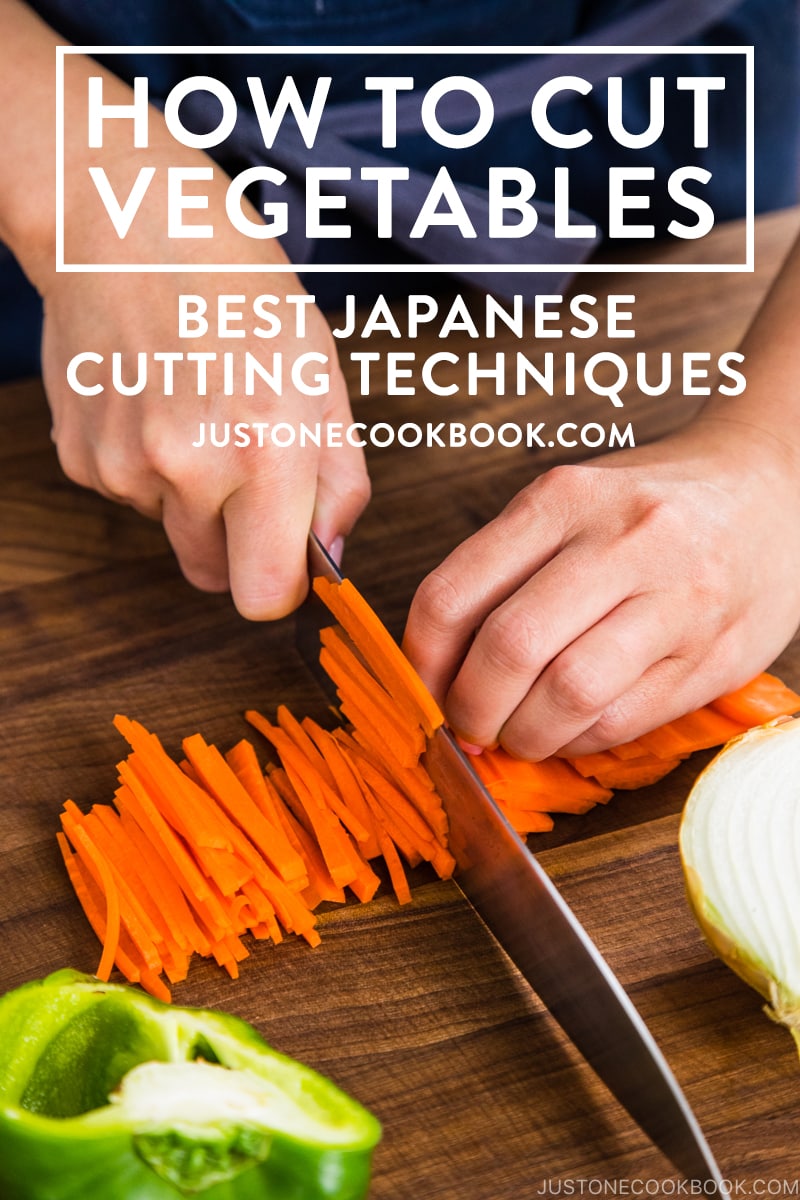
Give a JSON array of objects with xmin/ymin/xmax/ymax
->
[{"xmin": 0, "ymin": 971, "xmax": 380, "ymax": 1200}]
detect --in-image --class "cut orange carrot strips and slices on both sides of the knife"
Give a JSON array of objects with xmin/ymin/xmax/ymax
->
[{"xmin": 56, "ymin": 578, "xmax": 800, "ymax": 1000}]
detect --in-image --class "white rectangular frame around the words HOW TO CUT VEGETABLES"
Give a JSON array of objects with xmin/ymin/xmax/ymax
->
[{"xmin": 55, "ymin": 46, "xmax": 756, "ymax": 275}]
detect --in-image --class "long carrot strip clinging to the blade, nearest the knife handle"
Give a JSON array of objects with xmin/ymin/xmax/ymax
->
[{"xmin": 313, "ymin": 578, "xmax": 444, "ymax": 736}]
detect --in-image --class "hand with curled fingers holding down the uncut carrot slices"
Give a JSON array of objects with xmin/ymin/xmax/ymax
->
[{"xmin": 404, "ymin": 416, "xmax": 800, "ymax": 758}]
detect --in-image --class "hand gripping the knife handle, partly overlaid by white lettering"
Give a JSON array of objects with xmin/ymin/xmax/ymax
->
[{"xmin": 21, "ymin": 56, "xmax": 368, "ymax": 619}]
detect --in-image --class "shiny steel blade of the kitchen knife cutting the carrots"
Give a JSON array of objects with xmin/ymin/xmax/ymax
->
[{"xmin": 304, "ymin": 534, "xmax": 727, "ymax": 1196}]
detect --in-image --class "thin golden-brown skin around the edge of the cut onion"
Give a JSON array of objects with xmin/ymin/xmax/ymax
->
[{"xmin": 680, "ymin": 718, "xmax": 800, "ymax": 1052}]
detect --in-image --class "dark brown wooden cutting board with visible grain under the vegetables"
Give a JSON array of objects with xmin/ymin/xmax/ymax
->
[{"xmin": 0, "ymin": 212, "xmax": 800, "ymax": 1200}]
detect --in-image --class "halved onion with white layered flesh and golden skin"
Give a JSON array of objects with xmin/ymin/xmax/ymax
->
[{"xmin": 680, "ymin": 719, "xmax": 800, "ymax": 1049}]
